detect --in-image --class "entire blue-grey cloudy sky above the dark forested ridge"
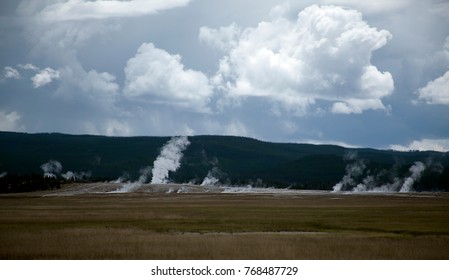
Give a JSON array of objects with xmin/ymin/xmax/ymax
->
[{"xmin": 0, "ymin": 0, "xmax": 449, "ymax": 151}]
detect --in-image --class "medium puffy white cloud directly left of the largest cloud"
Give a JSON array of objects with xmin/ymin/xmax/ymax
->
[{"xmin": 124, "ymin": 43, "xmax": 212, "ymax": 112}]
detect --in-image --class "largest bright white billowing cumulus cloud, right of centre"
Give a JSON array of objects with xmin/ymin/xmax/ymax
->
[{"xmin": 200, "ymin": 5, "xmax": 394, "ymax": 114}]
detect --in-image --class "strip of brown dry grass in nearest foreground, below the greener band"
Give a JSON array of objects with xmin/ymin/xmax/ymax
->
[{"xmin": 0, "ymin": 229, "xmax": 449, "ymax": 259}]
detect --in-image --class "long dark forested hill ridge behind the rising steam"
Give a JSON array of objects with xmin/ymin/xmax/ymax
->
[{"xmin": 0, "ymin": 132, "xmax": 449, "ymax": 191}]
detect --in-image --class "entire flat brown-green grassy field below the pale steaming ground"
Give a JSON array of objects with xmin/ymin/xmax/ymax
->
[{"xmin": 0, "ymin": 190, "xmax": 449, "ymax": 259}]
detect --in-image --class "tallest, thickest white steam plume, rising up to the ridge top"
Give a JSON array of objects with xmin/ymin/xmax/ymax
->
[{"xmin": 151, "ymin": 136, "xmax": 190, "ymax": 184}]
